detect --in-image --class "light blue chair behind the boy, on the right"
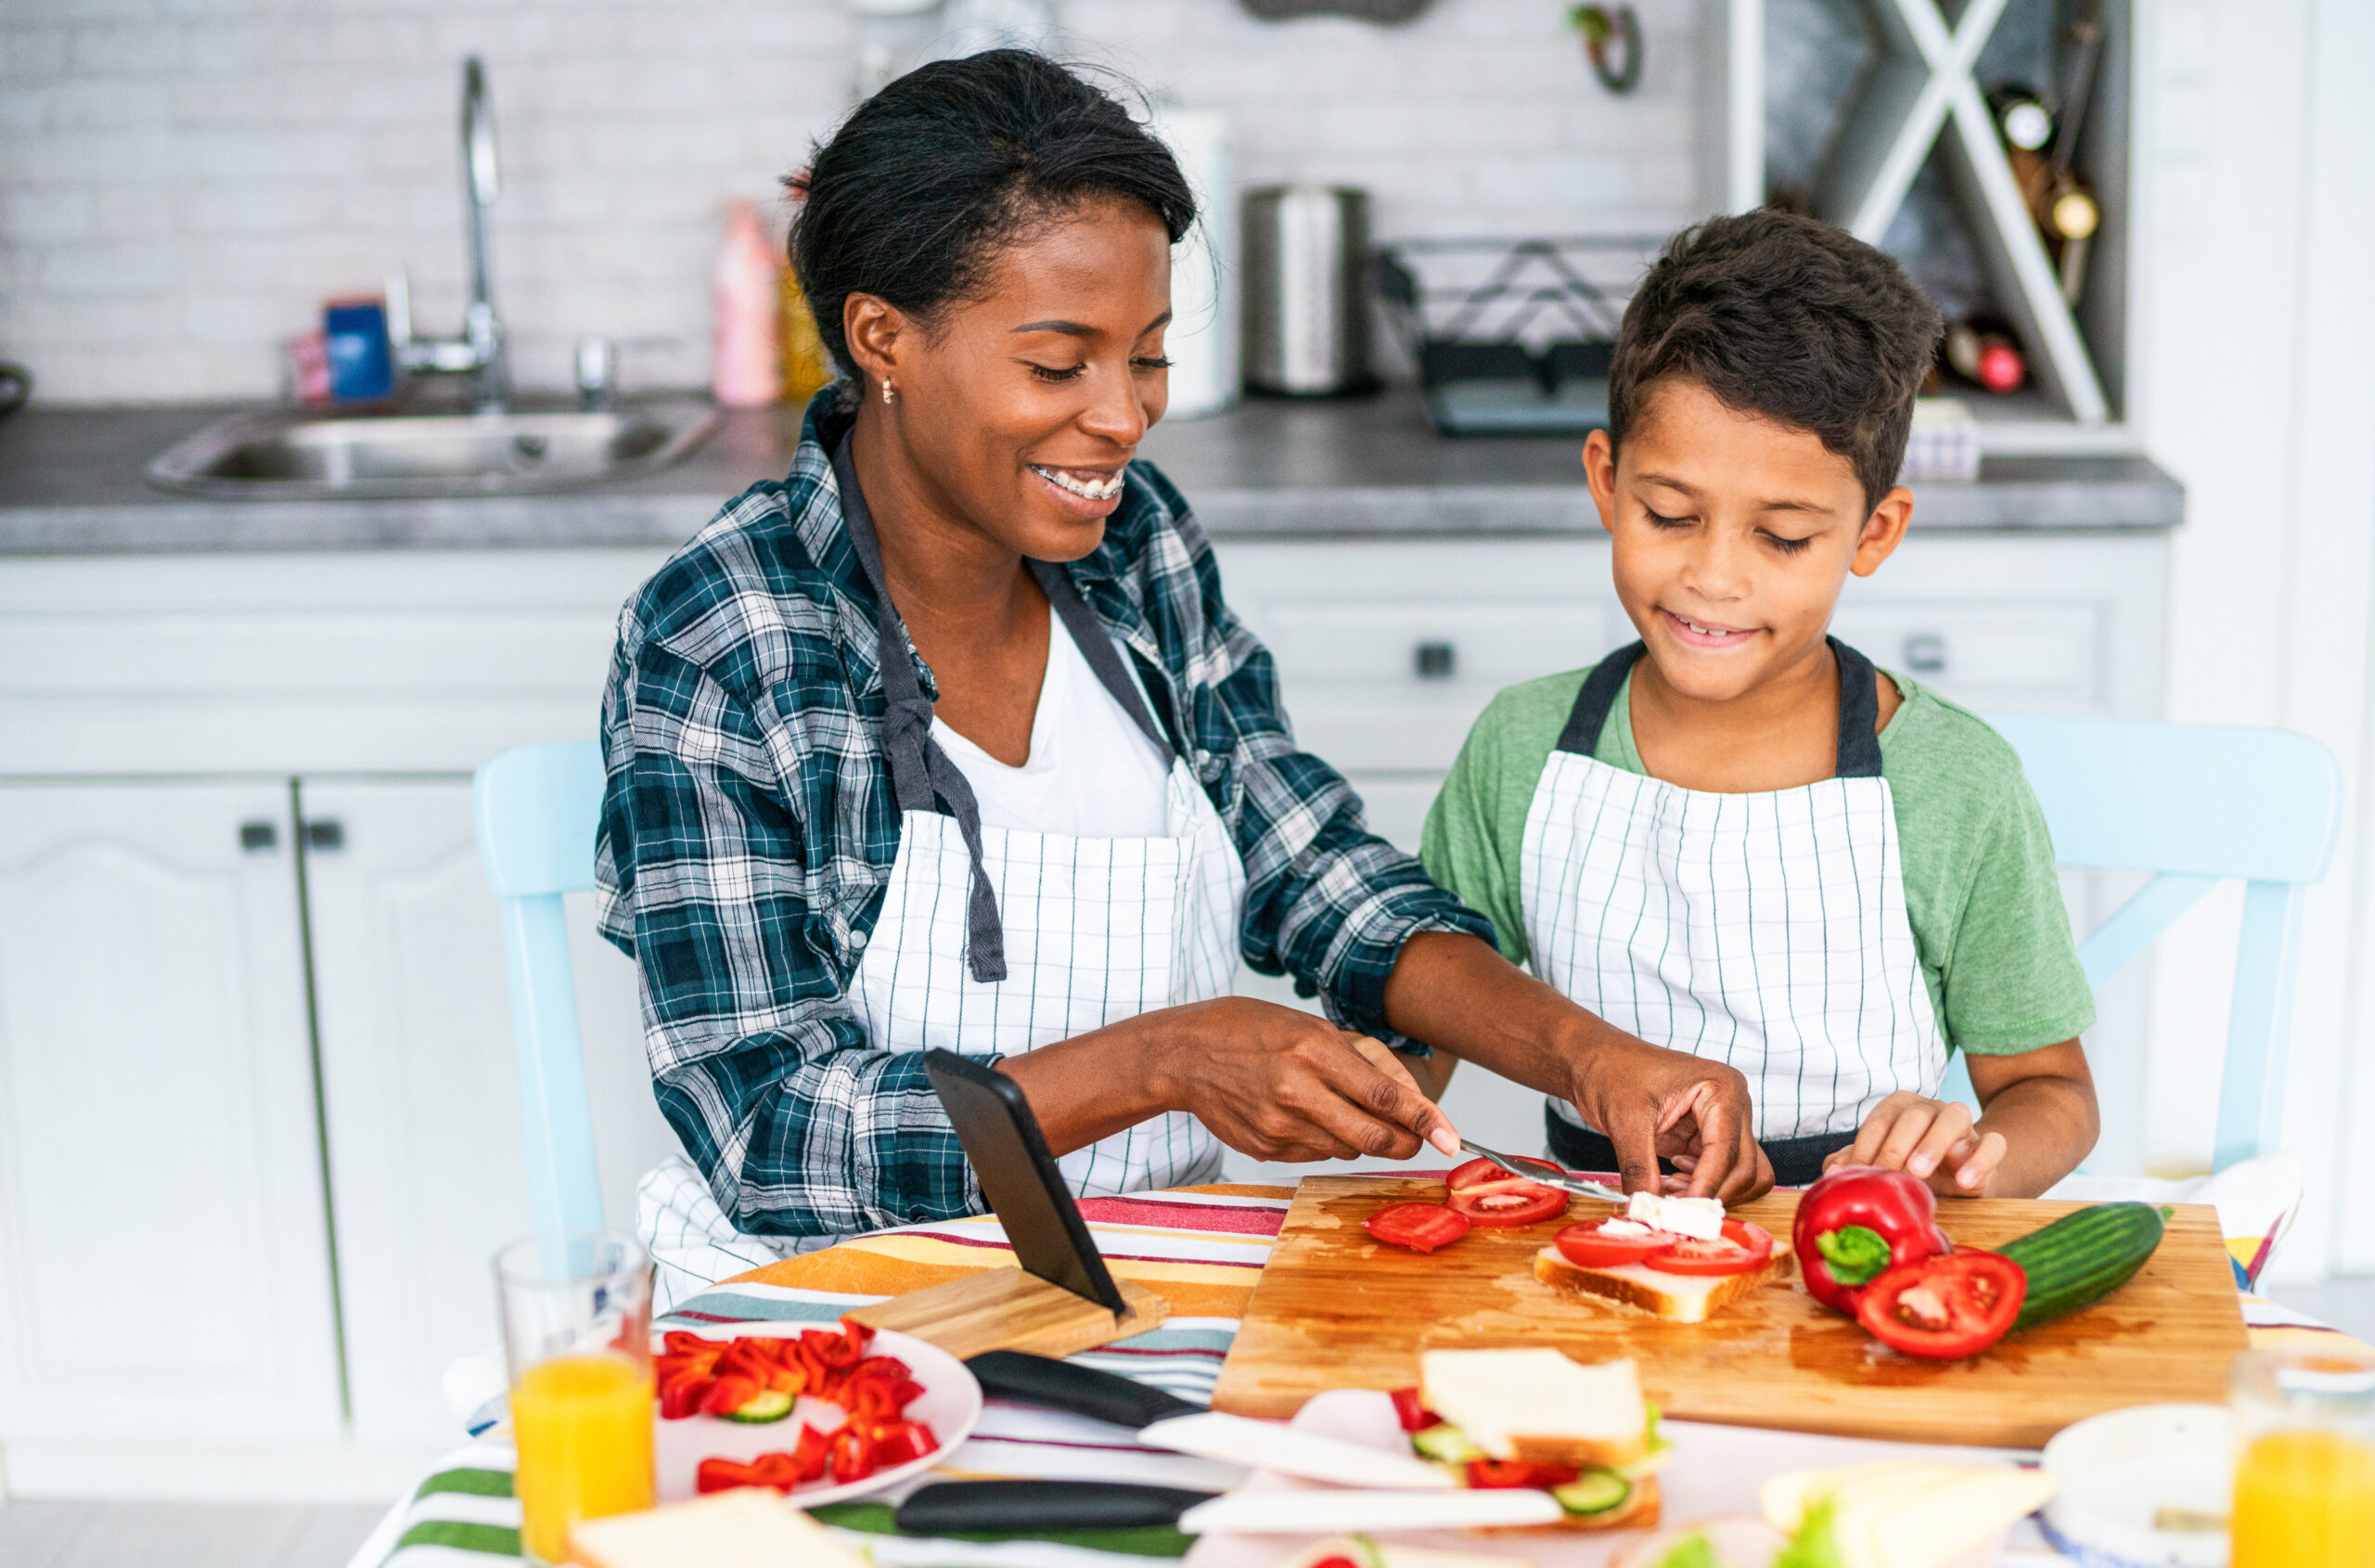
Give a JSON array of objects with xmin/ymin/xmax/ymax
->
[{"xmin": 1947, "ymin": 715, "xmax": 2342, "ymax": 1169}]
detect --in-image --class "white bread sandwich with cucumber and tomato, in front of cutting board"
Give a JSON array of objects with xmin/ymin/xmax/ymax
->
[{"xmin": 1394, "ymin": 1349, "xmax": 1672, "ymax": 1530}]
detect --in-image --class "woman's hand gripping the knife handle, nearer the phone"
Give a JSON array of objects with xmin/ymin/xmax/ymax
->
[{"xmin": 1142, "ymin": 996, "xmax": 1460, "ymax": 1162}]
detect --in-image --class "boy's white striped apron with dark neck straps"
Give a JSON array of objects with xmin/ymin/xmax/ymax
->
[{"xmin": 1520, "ymin": 639, "xmax": 1945, "ymax": 1186}]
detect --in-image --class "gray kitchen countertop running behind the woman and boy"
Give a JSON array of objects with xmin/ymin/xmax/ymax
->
[{"xmin": 0, "ymin": 392, "xmax": 2185, "ymax": 556}]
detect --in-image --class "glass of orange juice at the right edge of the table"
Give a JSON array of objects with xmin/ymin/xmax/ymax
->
[{"xmin": 2227, "ymin": 1349, "xmax": 2375, "ymax": 1568}]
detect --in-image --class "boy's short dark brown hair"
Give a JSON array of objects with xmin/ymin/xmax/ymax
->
[{"xmin": 1608, "ymin": 212, "xmax": 1941, "ymax": 508}]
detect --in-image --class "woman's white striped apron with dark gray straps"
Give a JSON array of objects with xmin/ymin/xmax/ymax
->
[{"xmin": 636, "ymin": 444, "xmax": 1244, "ymax": 1311}]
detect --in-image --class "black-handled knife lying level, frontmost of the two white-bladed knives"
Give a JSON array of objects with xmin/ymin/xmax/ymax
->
[{"xmin": 893, "ymin": 1480, "xmax": 1562, "ymax": 1535}]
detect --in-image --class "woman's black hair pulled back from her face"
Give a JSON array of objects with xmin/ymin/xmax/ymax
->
[{"xmin": 786, "ymin": 50, "xmax": 1195, "ymax": 378}]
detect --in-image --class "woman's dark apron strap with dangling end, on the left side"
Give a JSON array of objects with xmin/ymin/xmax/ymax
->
[{"xmin": 834, "ymin": 435, "xmax": 1007, "ymax": 986}]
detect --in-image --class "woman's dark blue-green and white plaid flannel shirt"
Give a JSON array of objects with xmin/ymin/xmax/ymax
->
[{"xmin": 597, "ymin": 397, "xmax": 1492, "ymax": 1236}]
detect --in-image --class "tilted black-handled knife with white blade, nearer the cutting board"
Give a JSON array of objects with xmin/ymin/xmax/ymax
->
[{"xmin": 964, "ymin": 1349, "xmax": 1456, "ymax": 1492}]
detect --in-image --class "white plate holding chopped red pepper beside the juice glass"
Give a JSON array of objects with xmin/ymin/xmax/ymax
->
[{"xmin": 653, "ymin": 1323, "xmax": 981, "ymax": 1509}]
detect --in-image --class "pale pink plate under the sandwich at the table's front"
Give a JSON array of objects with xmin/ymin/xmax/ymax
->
[{"xmin": 1183, "ymin": 1387, "xmax": 2052, "ymax": 1568}]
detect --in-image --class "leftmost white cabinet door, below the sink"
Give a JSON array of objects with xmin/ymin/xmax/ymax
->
[{"xmin": 0, "ymin": 779, "xmax": 340, "ymax": 1444}]
